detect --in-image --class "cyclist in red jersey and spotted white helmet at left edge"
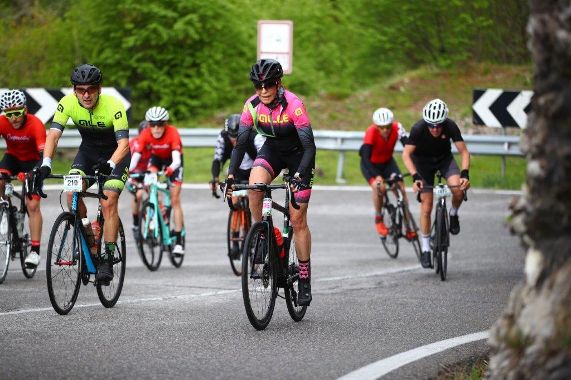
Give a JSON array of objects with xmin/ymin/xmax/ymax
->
[{"xmin": 0, "ymin": 90, "xmax": 46, "ymax": 267}]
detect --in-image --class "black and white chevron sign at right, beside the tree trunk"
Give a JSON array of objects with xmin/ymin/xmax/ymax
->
[{"xmin": 472, "ymin": 88, "xmax": 533, "ymax": 128}]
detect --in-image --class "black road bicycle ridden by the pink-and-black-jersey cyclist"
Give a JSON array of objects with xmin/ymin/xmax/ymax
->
[{"xmin": 228, "ymin": 176, "xmax": 307, "ymax": 330}]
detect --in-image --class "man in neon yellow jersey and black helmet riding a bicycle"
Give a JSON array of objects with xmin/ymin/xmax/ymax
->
[{"xmin": 36, "ymin": 64, "xmax": 131, "ymax": 285}]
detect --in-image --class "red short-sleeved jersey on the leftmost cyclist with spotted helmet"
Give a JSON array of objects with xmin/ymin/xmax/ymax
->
[{"xmin": 0, "ymin": 113, "xmax": 46, "ymax": 161}]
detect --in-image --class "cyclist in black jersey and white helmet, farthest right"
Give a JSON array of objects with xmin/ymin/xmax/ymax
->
[{"xmin": 403, "ymin": 99, "xmax": 470, "ymax": 268}]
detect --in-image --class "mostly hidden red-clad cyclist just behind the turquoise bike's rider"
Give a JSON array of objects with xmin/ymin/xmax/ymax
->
[{"xmin": 125, "ymin": 120, "xmax": 151, "ymax": 237}]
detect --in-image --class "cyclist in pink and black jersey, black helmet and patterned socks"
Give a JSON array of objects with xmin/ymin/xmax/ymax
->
[{"xmin": 227, "ymin": 59, "xmax": 316, "ymax": 306}]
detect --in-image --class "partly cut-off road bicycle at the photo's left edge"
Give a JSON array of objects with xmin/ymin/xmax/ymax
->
[{"xmin": 0, "ymin": 173, "xmax": 36, "ymax": 284}]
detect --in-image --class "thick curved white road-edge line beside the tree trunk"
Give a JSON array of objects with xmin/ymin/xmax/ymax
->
[{"xmin": 339, "ymin": 331, "xmax": 488, "ymax": 380}]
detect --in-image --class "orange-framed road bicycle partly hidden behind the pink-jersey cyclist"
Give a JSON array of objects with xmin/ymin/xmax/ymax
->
[{"xmin": 226, "ymin": 190, "xmax": 252, "ymax": 276}]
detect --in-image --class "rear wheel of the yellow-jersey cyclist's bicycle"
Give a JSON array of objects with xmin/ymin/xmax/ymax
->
[{"xmin": 97, "ymin": 219, "xmax": 127, "ymax": 308}]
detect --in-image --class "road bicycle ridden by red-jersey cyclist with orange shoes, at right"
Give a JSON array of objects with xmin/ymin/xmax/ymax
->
[{"xmin": 377, "ymin": 175, "xmax": 421, "ymax": 261}]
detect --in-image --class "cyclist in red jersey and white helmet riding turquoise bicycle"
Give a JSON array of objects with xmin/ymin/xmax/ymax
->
[{"xmin": 129, "ymin": 107, "xmax": 184, "ymax": 255}]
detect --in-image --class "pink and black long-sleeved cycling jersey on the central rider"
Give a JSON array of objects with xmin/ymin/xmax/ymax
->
[{"xmin": 228, "ymin": 88, "xmax": 315, "ymax": 176}]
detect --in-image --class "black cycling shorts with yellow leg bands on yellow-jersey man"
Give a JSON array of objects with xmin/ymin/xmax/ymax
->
[{"xmin": 69, "ymin": 146, "xmax": 131, "ymax": 193}]
